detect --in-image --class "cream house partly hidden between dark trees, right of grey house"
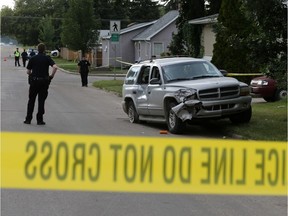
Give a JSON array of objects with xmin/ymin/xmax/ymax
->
[{"xmin": 188, "ymin": 14, "xmax": 218, "ymax": 60}]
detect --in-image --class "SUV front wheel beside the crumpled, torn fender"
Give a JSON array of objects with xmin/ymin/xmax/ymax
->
[{"xmin": 166, "ymin": 102, "xmax": 185, "ymax": 134}]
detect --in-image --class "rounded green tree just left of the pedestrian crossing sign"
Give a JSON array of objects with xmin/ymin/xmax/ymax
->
[{"xmin": 61, "ymin": 0, "xmax": 98, "ymax": 55}]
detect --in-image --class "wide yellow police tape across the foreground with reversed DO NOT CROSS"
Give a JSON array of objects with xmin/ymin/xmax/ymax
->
[{"xmin": 1, "ymin": 132, "xmax": 287, "ymax": 195}]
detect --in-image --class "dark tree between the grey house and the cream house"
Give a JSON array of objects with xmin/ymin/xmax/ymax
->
[{"xmin": 169, "ymin": 0, "xmax": 205, "ymax": 57}]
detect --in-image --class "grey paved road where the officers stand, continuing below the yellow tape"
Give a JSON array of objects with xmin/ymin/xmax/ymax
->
[{"xmin": 1, "ymin": 47, "xmax": 287, "ymax": 216}]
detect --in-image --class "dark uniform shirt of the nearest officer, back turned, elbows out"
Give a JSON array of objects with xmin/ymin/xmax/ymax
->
[{"xmin": 27, "ymin": 53, "xmax": 55, "ymax": 77}]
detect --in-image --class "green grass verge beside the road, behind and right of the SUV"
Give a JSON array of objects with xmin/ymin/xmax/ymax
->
[{"xmin": 93, "ymin": 80, "xmax": 287, "ymax": 141}]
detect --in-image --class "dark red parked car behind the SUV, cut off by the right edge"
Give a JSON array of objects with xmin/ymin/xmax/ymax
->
[{"xmin": 250, "ymin": 76, "xmax": 287, "ymax": 102}]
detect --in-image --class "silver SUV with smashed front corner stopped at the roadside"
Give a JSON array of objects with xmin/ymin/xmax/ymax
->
[{"xmin": 122, "ymin": 57, "xmax": 252, "ymax": 133}]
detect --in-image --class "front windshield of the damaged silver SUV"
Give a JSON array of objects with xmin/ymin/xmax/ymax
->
[{"xmin": 162, "ymin": 61, "xmax": 223, "ymax": 82}]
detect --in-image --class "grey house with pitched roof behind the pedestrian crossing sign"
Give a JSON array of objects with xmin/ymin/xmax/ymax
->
[{"xmin": 102, "ymin": 10, "xmax": 179, "ymax": 67}]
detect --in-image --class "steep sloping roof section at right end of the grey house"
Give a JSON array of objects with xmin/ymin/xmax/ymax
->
[{"xmin": 132, "ymin": 10, "xmax": 179, "ymax": 41}]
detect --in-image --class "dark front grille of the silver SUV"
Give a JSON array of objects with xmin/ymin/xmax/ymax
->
[{"xmin": 198, "ymin": 86, "xmax": 240, "ymax": 101}]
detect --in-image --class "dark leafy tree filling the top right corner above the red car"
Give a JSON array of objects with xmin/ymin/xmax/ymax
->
[{"xmin": 244, "ymin": 0, "xmax": 287, "ymax": 88}]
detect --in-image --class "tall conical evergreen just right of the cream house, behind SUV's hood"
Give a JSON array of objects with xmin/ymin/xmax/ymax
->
[{"xmin": 212, "ymin": 0, "xmax": 258, "ymax": 72}]
